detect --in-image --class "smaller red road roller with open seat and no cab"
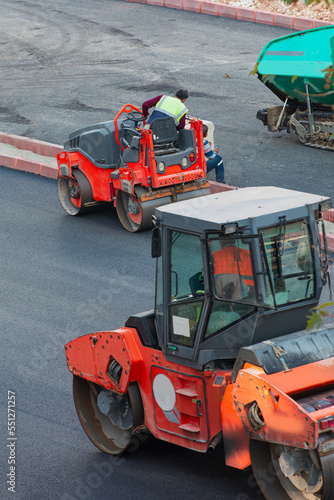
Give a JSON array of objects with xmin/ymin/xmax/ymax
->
[{"xmin": 57, "ymin": 104, "xmax": 210, "ymax": 232}]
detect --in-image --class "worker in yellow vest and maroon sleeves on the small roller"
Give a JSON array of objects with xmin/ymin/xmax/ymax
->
[{"xmin": 142, "ymin": 89, "xmax": 189, "ymax": 130}]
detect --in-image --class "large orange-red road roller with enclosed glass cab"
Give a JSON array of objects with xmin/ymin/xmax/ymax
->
[{"xmin": 65, "ymin": 186, "xmax": 334, "ymax": 500}]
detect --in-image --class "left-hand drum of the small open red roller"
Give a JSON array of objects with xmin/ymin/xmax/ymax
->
[{"xmin": 58, "ymin": 169, "xmax": 94, "ymax": 215}]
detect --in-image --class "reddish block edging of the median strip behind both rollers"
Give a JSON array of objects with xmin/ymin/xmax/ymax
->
[{"xmin": 0, "ymin": 132, "xmax": 334, "ymax": 252}]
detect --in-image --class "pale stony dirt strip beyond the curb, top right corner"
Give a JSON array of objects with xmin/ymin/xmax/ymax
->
[{"xmin": 216, "ymin": 0, "xmax": 334, "ymax": 24}]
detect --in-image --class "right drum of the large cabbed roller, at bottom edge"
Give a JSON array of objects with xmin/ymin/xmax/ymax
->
[{"xmin": 250, "ymin": 440, "xmax": 333, "ymax": 500}]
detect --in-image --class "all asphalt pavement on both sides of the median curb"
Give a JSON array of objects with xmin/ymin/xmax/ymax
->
[{"xmin": 0, "ymin": 0, "xmax": 334, "ymax": 500}]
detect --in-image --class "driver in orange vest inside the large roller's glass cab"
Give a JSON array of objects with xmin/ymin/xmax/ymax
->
[{"xmin": 213, "ymin": 239, "xmax": 254, "ymax": 300}]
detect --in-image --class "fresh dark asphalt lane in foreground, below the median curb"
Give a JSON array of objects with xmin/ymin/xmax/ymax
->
[{"xmin": 0, "ymin": 167, "xmax": 261, "ymax": 500}]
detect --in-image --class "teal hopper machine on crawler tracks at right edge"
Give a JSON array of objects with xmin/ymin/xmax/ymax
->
[{"xmin": 256, "ymin": 26, "xmax": 334, "ymax": 151}]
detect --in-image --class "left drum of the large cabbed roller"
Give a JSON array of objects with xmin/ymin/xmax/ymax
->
[{"xmin": 73, "ymin": 376, "xmax": 144, "ymax": 455}]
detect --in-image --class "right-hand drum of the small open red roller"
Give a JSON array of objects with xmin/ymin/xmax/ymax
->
[{"xmin": 116, "ymin": 190, "xmax": 154, "ymax": 233}]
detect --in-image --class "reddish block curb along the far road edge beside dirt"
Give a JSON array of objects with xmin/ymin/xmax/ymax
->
[{"xmin": 124, "ymin": 0, "xmax": 333, "ymax": 31}]
